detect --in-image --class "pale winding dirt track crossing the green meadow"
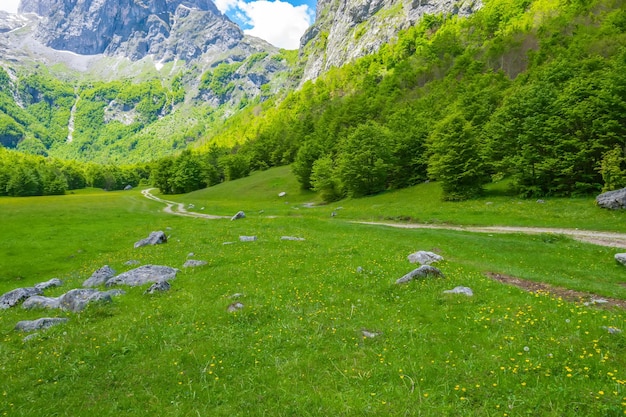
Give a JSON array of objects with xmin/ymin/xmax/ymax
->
[{"xmin": 141, "ymin": 188, "xmax": 626, "ymax": 249}]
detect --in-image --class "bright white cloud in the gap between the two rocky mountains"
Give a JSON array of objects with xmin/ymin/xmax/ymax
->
[{"xmin": 235, "ymin": 0, "xmax": 313, "ymax": 49}]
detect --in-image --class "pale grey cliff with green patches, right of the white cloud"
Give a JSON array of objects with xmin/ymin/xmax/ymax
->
[{"xmin": 300, "ymin": 0, "xmax": 482, "ymax": 81}]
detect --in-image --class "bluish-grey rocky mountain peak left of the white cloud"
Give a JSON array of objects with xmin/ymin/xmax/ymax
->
[{"xmin": 19, "ymin": 0, "xmax": 244, "ymax": 61}]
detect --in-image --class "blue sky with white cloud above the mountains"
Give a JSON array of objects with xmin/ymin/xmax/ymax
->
[{"xmin": 0, "ymin": 0, "xmax": 317, "ymax": 49}]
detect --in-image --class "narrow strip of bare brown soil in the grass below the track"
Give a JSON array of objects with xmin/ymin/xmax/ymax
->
[{"xmin": 485, "ymin": 272, "xmax": 626, "ymax": 309}]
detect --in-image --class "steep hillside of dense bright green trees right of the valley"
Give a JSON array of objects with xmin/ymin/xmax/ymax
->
[{"xmin": 152, "ymin": 0, "xmax": 626, "ymax": 201}]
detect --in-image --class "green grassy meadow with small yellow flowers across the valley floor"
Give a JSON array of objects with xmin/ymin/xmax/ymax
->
[{"xmin": 0, "ymin": 168, "xmax": 626, "ymax": 416}]
